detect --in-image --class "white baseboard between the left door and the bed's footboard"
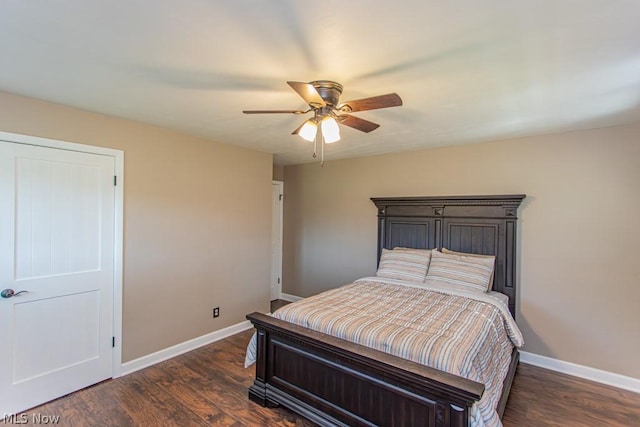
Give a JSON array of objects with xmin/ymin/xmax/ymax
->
[{"xmin": 120, "ymin": 320, "xmax": 253, "ymax": 375}]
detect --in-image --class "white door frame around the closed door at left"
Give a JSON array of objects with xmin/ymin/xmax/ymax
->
[{"xmin": 0, "ymin": 131, "xmax": 124, "ymax": 378}]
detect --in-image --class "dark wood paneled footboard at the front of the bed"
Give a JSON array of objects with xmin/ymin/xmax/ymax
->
[{"xmin": 247, "ymin": 313, "xmax": 500, "ymax": 426}]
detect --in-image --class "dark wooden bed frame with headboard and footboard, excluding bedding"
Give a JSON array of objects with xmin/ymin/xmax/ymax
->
[{"xmin": 247, "ymin": 195, "xmax": 525, "ymax": 426}]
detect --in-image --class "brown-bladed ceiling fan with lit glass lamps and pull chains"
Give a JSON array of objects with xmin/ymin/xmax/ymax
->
[{"xmin": 242, "ymin": 80, "xmax": 402, "ymax": 163}]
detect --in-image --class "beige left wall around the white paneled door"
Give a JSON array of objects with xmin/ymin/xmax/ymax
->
[{"xmin": 0, "ymin": 92, "xmax": 272, "ymax": 362}]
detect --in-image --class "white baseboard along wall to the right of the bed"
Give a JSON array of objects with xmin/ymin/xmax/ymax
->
[{"xmin": 520, "ymin": 351, "xmax": 640, "ymax": 393}]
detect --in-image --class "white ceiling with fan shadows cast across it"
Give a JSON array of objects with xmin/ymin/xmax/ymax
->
[{"xmin": 0, "ymin": 0, "xmax": 640, "ymax": 165}]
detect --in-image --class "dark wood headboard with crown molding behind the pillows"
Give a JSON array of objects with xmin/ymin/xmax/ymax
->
[{"xmin": 371, "ymin": 194, "xmax": 525, "ymax": 316}]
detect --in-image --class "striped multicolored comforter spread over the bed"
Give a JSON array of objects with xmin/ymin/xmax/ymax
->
[{"xmin": 247, "ymin": 277, "xmax": 523, "ymax": 426}]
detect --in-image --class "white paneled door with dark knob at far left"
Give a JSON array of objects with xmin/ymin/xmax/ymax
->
[{"xmin": 0, "ymin": 141, "xmax": 115, "ymax": 414}]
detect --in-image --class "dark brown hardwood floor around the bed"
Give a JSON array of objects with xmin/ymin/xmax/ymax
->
[{"xmin": 11, "ymin": 306, "xmax": 640, "ymax": 427}]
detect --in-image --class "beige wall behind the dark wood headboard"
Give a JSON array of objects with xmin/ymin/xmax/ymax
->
[{"xmin": 283, "ymin": 125, "xmax": 640, "ymax": 378}]
